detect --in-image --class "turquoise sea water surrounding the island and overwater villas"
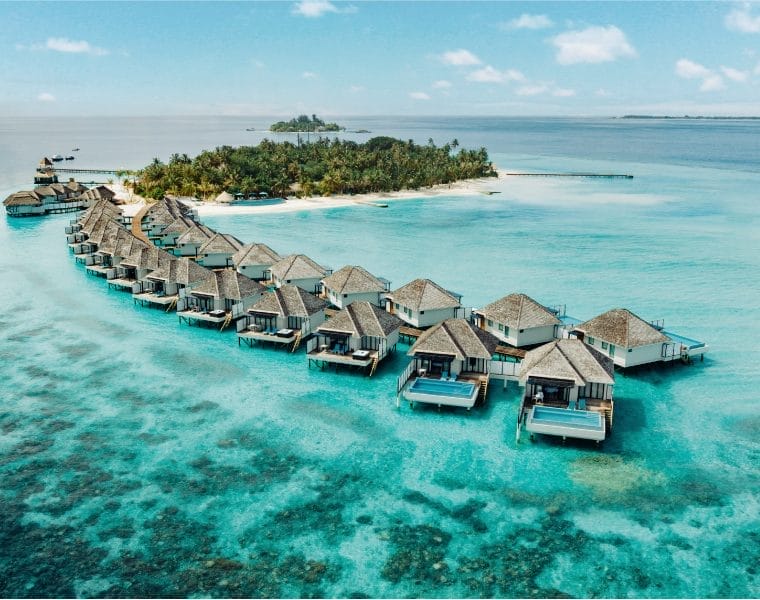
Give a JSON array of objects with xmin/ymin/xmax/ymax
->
[{"xmin": 0, "ymin": 120, "xmax": 760, "ymax": 597}]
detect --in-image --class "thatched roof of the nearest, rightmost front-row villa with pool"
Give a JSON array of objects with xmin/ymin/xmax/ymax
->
[{"xmin": 520, "ymin": 339, "xmax": 615, "ymax": 387}]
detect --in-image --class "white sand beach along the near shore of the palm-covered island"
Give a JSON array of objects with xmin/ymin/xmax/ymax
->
[{"xmin": 195, "ymin": 171, "xmax": 505, "ymax": 217}]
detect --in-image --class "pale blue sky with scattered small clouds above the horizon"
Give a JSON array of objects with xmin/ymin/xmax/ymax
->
[{"xmin": 0, "ymin": 0, "xmax": 760, "ymax": 117}]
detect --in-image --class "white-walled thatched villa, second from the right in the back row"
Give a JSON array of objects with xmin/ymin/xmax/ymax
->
[{"xmin": 472, "ymin": 294, "xmax": 561, "ymax": 348}]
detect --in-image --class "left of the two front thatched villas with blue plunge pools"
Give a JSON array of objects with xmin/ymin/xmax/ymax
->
[{"xmin": 398, "ymin": 319, "xmax": 499, "ymax": 410}]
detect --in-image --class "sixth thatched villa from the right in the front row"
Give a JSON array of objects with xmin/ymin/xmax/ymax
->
[{"xmin": 132, "ymin": 258, "xmax": 213, "ymax": 312}]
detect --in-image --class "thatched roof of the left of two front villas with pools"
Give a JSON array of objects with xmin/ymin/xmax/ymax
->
[{"xmin": 408, "ymin": 319, "xmax": 499, "ymax": 360}]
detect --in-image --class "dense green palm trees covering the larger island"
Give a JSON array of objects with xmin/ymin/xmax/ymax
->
[{"xmin": 135, "ymin": 137, "xmax": 496, "ymax": 200}]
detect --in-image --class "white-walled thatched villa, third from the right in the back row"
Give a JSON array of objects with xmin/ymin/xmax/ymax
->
[{"xmin": 386, "ymin": 279, "xmax": 466, "ymax": 328}]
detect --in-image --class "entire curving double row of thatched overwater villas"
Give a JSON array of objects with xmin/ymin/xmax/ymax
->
[{"xmin": 59, "ymin": 197, "xmax": 708, "ymax": 442}]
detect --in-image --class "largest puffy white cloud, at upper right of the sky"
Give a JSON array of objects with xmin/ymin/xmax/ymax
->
[{"xmin": 552, "ymin": 25, "xmax": 636, "ymax": 65}]
